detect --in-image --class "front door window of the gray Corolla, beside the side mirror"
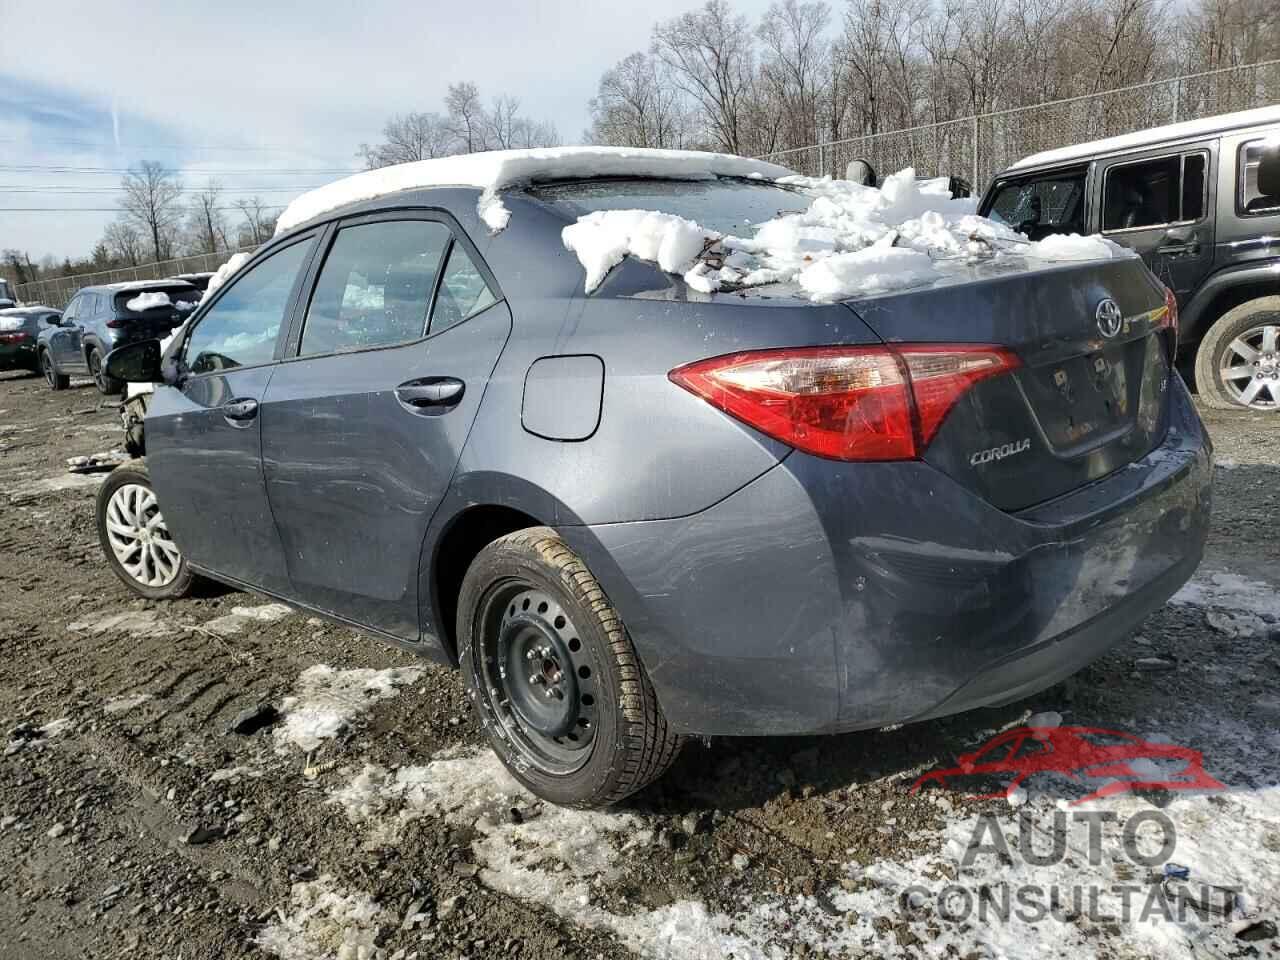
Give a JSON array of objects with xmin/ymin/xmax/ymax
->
[{"xmin": 187, "ymin": 241, "xmax": 311, "ymax": 374}]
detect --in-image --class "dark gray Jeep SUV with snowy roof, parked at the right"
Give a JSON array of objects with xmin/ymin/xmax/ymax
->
[{"xmin": 979, "ymin": 106, "xmax": 1280, "ymax": 410}]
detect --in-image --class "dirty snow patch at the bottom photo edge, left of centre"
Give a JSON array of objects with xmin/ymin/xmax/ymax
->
[{"xmin": 256, "ymin": 874, "xmax": 388, "ymax": 960}]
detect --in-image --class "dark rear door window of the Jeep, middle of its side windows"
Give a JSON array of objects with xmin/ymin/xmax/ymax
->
[{"xmin": 1102, "ymin": 152, "xmax": 1207, "ymax": 233}]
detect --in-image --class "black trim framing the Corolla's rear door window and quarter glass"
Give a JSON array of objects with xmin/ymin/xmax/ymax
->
[{"xmin": 279, "ymin": 206, "xmax": 506, "ymax": 364}]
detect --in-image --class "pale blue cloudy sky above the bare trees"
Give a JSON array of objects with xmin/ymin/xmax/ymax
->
[{"xmin": 0, "ymin": 0, "xmax": 768, "ymax": 259}]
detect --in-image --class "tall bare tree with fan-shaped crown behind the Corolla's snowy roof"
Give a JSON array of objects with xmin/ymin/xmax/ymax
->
[{"xmin": 653, "ymin": 0, "xmax": 754, "ymax": 154}]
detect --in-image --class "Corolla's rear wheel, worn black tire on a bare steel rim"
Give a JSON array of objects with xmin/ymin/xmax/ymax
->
[{"xmin": 457, "ymin": 527, "xmax": 681, "ymax": 808}]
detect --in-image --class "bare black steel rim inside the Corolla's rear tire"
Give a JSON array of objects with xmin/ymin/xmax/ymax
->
[{"xmin": 480, "ymin": 580, "xmax": 596, "ymax": 774}]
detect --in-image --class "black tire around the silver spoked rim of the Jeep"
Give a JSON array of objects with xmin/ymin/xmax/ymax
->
[{"xmin": 1196, "ymin": 297, "xmax": 1280, "ymax": 411}]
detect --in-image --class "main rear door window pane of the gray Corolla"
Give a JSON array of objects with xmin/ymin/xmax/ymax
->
[{"xmin": 302, "ymin": 220, "xmax": 451, "ymax": 357}]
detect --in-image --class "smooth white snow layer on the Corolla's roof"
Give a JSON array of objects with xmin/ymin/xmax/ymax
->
[{"xmin": 275, "ymin": 147, "xmax": 794, "ymax": 236}]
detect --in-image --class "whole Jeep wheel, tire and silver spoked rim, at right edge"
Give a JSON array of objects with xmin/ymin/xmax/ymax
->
[{"xmin": 1196, "ymin": 297, "xmax": 1280, "ymax": 411}]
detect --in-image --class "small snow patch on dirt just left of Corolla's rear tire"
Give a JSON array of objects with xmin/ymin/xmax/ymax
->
[{"xmin": 275, "ymin": 663, "xmax": 424, "ymax": 750}]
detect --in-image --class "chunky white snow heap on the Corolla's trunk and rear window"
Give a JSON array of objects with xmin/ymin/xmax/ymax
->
[{"xmin": 562, "ymin": 168, "xmax": 1133, "ymax": 301}]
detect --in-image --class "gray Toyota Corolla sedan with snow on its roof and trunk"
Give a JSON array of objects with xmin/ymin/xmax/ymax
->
[{"xmin": 99, "ymin": 152, "xmax": 1212, "ymax": 805}]
